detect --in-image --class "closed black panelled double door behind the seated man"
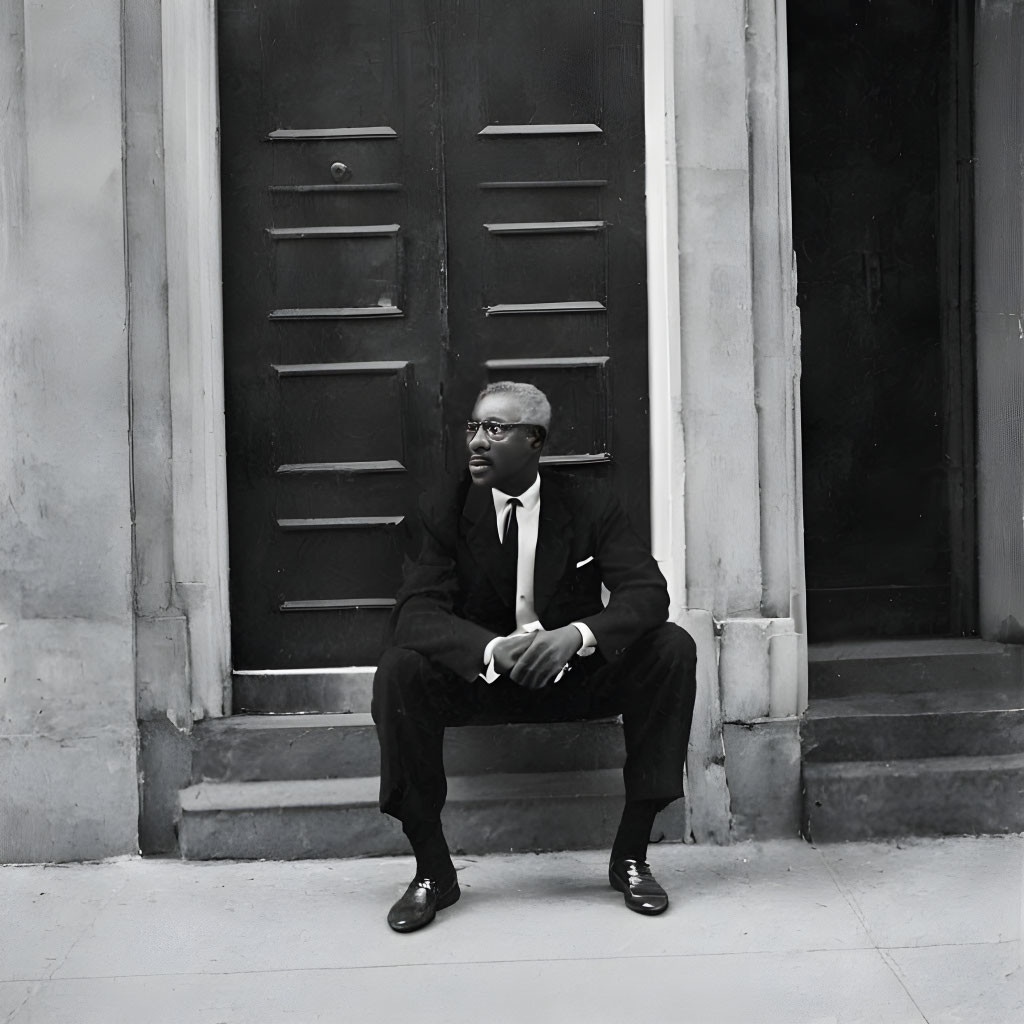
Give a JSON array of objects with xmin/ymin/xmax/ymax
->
[{"xmin": 218, "ymin": 0, "xmax": 648, "ymax": 669}]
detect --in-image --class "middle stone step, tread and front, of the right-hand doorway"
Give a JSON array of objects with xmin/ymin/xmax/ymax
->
[{"xmin": 800, "ymin": 688, "xmax": 1024, "ymax": 762}]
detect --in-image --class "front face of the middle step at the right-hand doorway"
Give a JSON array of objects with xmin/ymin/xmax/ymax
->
[{"xmin": 800, "ymin": 711, "xmax": 1024, "ymax": 762}]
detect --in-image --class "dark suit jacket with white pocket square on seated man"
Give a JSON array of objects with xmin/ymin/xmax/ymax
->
[{"xmin": 390, "ymin": 471, "xmax": 669, "ymax": 680}]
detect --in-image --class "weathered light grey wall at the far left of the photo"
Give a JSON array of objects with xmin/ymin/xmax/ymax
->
[{"xmin": 0, "ymin": 0, "xmax": 138, "ymax": 861}]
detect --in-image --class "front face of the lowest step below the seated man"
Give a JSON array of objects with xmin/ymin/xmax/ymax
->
[{"xmin": 179, "ymin": 796, "xmax": 667, "ymax": 860}]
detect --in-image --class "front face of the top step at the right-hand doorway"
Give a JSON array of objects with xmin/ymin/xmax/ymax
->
[{"xmin": 808, "ymin": 647, "xmax": 1024, "ymax": 699}]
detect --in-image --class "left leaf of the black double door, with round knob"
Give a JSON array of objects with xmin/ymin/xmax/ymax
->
[{"xmin": 218, "ymin": 0, "xmax": 443, "ymax": 669}]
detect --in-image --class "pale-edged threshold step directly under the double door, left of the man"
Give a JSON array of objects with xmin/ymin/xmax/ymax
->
[{"xmin": 231, "ymin": 667, "xmax": 374, "ymax": 715}]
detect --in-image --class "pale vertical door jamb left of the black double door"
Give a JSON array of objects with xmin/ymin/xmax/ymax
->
[{"xmin": 161, "ymin": 0, "xmax": 230, "ymax": 718}]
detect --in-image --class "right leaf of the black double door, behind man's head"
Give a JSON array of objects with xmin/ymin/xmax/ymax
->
[{"xmin": 443, "ymin": 0, "xmax": 649, "ymax": 532}]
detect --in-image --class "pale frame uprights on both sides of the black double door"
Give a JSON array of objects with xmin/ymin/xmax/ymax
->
[{"xmin": 161, "ymin": 0, "xmax": 686, "ymax": 717}]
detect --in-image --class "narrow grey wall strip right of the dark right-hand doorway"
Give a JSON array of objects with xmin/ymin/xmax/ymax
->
[{"xmin": 975, "ymin": 0, "xmax": 1024, "ymax": 643}]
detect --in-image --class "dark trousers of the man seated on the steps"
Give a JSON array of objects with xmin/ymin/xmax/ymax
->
[{"xmin": 371, "ymin": 623, "xmax": 696, "ymax": 823}]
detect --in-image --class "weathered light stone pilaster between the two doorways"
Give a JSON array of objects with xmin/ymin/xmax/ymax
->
[{"xmin": 674, "ymin": 0, "xmax": 807, "ymax": 842}]
